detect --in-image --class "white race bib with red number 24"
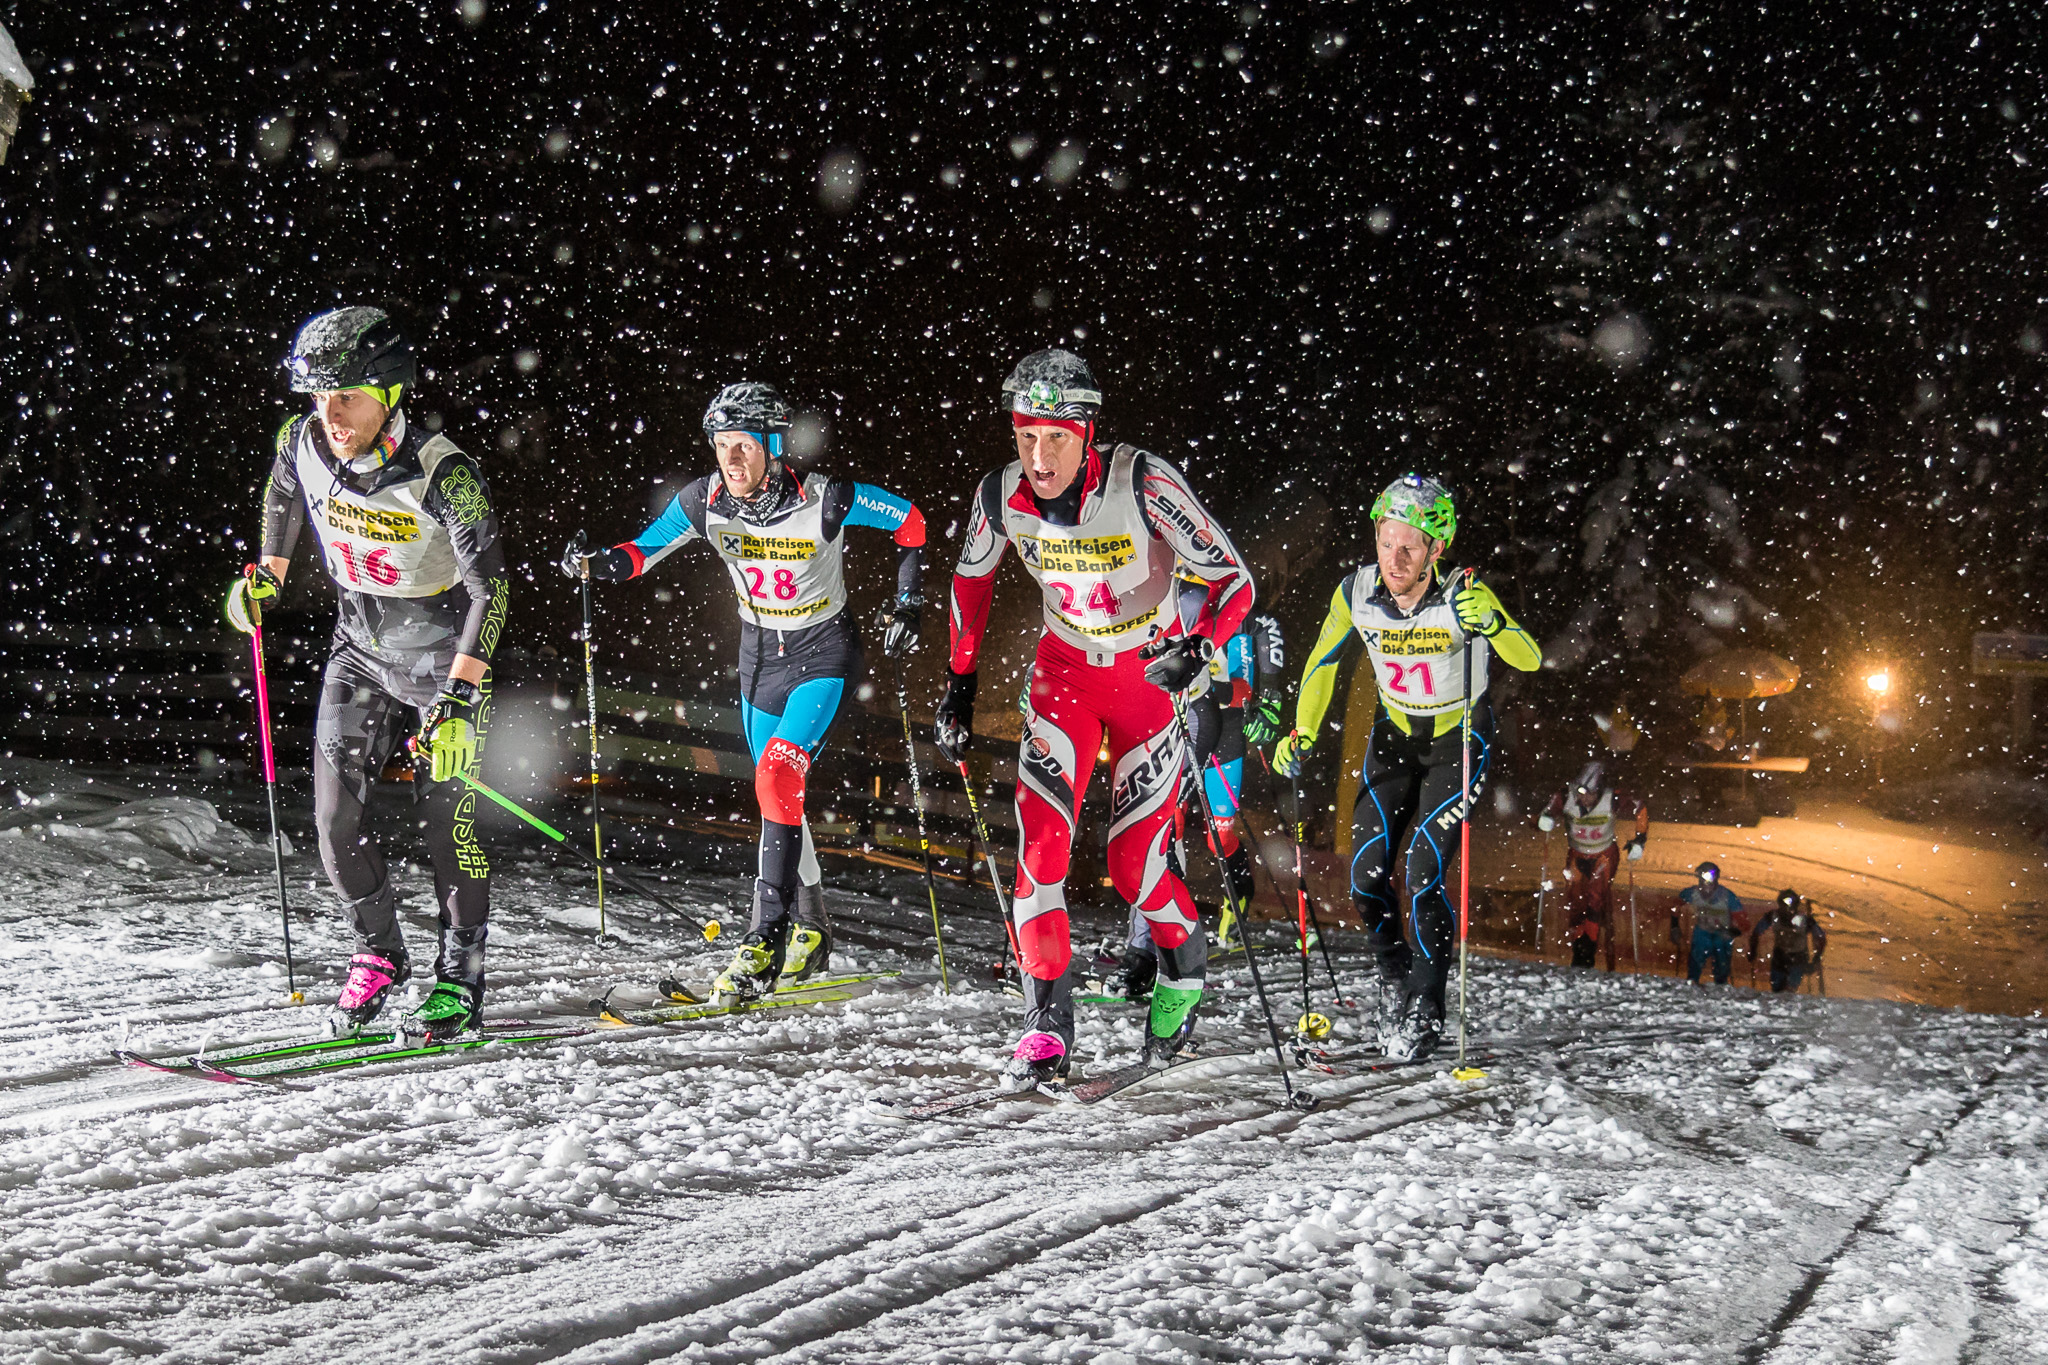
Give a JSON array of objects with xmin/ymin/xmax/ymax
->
[{"xmin": 1004, "ymin": 446, "xmax": 1174, "ymax": 663}]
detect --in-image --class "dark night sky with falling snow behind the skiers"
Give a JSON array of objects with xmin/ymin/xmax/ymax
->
[{"xmin": 0, "ymin": 0, "xmax": 2048, "ymax": 794}]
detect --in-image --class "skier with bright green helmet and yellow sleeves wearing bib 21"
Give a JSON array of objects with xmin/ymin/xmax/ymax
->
[{"xmin": 1274, "ymin": 475, "xmax": 1542, "ymax": 1062}]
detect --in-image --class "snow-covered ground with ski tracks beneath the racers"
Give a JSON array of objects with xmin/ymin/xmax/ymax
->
[{"xmin": 0, "ymin": 765, "xmax": 2048, "ymax": 1363}]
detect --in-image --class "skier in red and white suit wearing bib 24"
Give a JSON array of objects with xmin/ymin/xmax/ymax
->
[{"xmin": 934, "ymin": 350, "xmax": 1253, "ymax": 1089}]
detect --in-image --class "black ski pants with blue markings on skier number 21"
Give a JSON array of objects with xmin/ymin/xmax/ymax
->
[{"xmin": 1352, "ymin": 698, "xmax": 1493, "ymax": 1019}]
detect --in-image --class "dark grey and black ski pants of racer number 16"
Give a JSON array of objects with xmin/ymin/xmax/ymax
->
[{"xmin": 313, "ymin": 639, "xmax": 492, "ymax": 962}]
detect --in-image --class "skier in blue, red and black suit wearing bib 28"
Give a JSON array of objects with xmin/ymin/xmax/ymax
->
[{"xmin": 561, "ymin": 383, "xmax": 924, "ymax": 999}]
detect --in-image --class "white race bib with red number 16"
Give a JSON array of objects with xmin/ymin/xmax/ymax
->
[{"xmin": 293, "ymin": 424, "xmax": 459, "ymax": 598}]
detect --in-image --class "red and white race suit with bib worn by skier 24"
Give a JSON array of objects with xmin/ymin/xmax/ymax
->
[{"xmin": 950, "ymin": 446, "xmax": 1253, "ymax": 1010}]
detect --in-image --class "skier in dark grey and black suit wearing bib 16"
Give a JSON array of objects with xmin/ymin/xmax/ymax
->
[{"xmin": 227, "ymin": 307, "xmax": 510, "ymax": 1042}]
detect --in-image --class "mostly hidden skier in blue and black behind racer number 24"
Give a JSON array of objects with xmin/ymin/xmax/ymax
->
[{"xmin": 1106, "ymin": 575, "xmax": 1286, "ymax": 1001}]
